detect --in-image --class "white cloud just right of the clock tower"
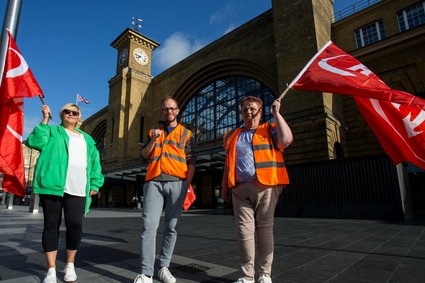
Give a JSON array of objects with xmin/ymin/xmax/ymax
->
[{"xmin": 155, "ymin": 32, "xmax": 205, "ymax": 69}]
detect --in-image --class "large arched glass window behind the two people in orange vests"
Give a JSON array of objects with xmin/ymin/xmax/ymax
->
[{"xmin": 180, "ymin": 76, "xmax": 275, "ymax": 142}]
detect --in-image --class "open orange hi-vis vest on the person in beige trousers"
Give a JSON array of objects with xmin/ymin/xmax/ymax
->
[{"xmin": 224, "ymin": 123, "xmax": 289, "ymax": 188}]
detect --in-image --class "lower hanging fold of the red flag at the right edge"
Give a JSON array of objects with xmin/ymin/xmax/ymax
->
[{"xmin": 354, "ymin": 97, "xmax": 425, "ymax": 169}]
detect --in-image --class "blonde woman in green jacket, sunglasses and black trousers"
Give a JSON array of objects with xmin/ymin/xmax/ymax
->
[{"xmin": 27, "ymin": 104, "xmax": 103, "ymax": 283}]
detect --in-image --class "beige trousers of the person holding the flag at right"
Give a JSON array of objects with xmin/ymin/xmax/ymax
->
[{"xmin": 232, "ymin": 183, "xmax": 282, "ymax": 279}]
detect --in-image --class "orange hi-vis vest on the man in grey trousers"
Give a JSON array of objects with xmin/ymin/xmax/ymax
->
[{"xmin": 146, "ymin": 124, "xmax": 192, "ymax": 181}]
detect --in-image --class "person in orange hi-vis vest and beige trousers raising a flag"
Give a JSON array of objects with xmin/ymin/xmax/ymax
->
[{"xmin": 222, "ymin": 96, "xmax": 293, "ymax": 283}]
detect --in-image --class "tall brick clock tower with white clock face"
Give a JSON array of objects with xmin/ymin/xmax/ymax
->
[{"xmin": 104, "ymin": 28, "xmax": 159, "ymax": 166}]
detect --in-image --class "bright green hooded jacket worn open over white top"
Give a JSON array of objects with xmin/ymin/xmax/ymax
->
[{"xmin": 27, "ymin": 123, "xmax": 104, "ymax": 215}]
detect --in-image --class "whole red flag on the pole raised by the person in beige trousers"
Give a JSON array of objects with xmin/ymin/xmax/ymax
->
[{"xmin": 289, "ymin": 42, "xmax": 425, "ymax": 169}]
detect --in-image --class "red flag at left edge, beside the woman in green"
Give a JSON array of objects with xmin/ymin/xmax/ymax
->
[{"xmin": 0, "ymin": 30, "xmax": 43, "ymax": 196}]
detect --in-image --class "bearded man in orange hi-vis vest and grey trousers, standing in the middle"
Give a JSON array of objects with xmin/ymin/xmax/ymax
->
[{"xmin": 134, "ymin": 97, "xmax": 196, "ymax": 283}]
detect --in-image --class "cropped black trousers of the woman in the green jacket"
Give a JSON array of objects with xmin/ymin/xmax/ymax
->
[{"xmin": 40, "ymin": 194, "xmax": 86, "ymax": 252}]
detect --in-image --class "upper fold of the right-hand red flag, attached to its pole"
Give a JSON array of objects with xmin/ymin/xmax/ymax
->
[{"xmin": 289, "ymin": 41, "xmax": 425, "ymax": 110}]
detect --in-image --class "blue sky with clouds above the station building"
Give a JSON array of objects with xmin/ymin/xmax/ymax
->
[{"xmin": 0, "ymin": 0, "xmax": 358, "ymax": 138}]
